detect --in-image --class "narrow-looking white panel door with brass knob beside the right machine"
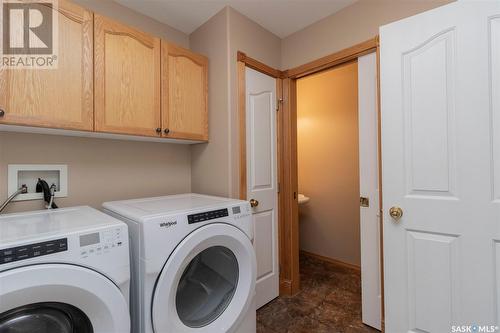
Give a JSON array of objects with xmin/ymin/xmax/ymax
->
[{"xmin": 246, "ymin": 68, "xmax": 279, "ymax": 308}]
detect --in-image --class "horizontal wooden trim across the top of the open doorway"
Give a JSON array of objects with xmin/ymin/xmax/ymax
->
[{"xmin": 283, "ymin": 36, "xmax": 379, "ymax": 79}]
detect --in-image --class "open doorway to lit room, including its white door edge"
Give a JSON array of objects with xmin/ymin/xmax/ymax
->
[{"xmin": 296, "ymin": 54, "xmax": 381, "ymax": 332}]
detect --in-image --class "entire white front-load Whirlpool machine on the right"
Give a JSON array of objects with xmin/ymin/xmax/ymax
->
[{"xmin": 104, "ymin": 194, "xmax": 256, "ymax": 333}]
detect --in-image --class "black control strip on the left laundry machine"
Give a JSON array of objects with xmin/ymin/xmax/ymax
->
[{"xmin": 0, "ymin": 238, "xmax": 68, "ymax": 265}]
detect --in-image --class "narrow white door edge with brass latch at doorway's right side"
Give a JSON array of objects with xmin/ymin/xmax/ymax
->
[{"xmin": 358, "ymin": 53, "xmax": 382, "ymax": 330}]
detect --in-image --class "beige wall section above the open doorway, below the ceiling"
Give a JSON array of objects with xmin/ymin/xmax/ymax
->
[{"xmin": 281, "ymin": 0, "xmax": 451, "ymax": 69}]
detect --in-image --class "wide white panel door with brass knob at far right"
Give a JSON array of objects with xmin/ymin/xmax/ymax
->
[{"xmin": 380, "ymin": 1, "xmax": 500, "ymax": 333}]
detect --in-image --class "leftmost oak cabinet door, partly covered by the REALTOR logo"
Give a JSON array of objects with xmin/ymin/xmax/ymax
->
[{"xmin": 0, "ymin": 0, "xmax": 93, "ymax": 131}]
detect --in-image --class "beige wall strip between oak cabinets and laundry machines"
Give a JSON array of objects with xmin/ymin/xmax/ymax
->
[{"xmin": 0, "ymin": 133, "xmax": 191, "ymax": 212}]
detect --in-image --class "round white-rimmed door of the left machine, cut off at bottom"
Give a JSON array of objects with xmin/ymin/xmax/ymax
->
[{"xmin": 0, "ymin": 264, "xmax": 130, "ymax": 333}]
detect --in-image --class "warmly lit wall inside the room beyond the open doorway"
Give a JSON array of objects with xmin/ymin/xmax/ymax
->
[{"xmin": 297, "ymin": 62, "xmax": 360, "ymax": 265}]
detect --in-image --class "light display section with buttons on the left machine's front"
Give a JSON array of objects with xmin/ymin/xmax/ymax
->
[{"xmin": 79, "ymin": 228, "xmax": 123, "ymax": 258}]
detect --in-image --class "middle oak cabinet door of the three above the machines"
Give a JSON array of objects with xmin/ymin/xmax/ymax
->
[{"xmin": 94, "ymin": 15, "xmax": 161, "ymax": 136}]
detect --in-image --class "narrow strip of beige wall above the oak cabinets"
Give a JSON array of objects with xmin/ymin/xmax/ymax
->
[{"xmin": 72, "ymin": 0, "xmax": 189, "ymax": 47}]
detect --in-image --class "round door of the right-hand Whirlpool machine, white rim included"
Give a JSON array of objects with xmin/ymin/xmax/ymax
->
[{"xmin": 152, "ymin": 223, "xmax": 256, "ymax": 333}]
